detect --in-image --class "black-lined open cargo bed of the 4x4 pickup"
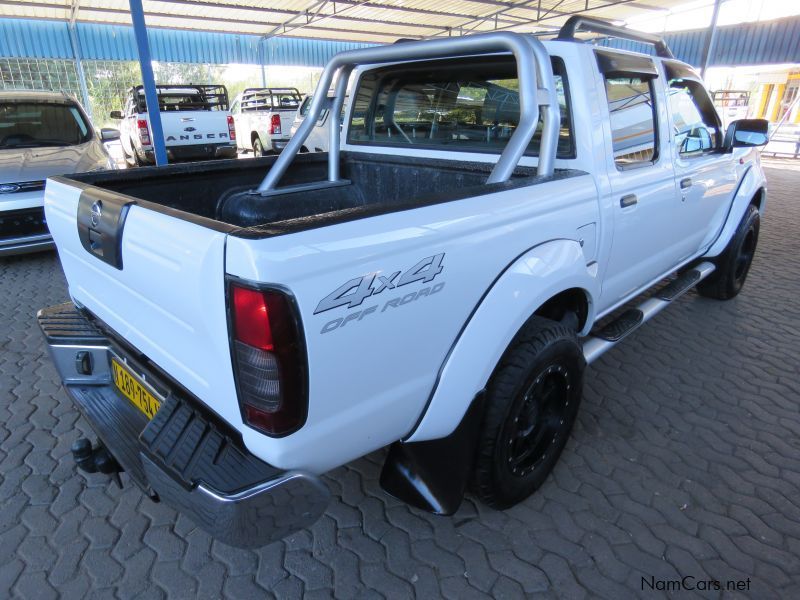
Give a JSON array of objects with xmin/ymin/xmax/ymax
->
[{"xmin": 67, "ymin": 152, "xmax": 581, "ymax": 237}]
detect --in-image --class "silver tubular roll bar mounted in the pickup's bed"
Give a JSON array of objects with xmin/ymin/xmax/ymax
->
[{"xmin": 257, "ymin": 32, "xmax": 561, "ymax": 195}]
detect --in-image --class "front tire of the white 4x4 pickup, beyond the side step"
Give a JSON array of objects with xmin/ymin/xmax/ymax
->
[{"xmin": 697, "ymin": 204, "xmax": 761, "ymax": 300}]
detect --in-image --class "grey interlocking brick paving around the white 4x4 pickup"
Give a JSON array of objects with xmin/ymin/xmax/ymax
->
[{"xmin": 0, "ymin": 169, "xmax": 800, "ymax": 600}]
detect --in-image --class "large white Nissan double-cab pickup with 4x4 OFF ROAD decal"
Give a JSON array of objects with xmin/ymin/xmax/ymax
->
[{"xmin": 39, "ymin": 19, "xmax": 766, "ymax": 546}]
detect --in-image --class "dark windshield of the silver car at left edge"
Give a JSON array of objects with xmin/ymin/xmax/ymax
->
[{"xmin": 0, "ymin": 102, "xmax": 92, "ymax": 149}]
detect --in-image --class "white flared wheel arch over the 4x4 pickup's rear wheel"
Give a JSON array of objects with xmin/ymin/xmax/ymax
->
[{"xmin": 405, "ymin": 239, "xmax": 598, "ymax": 442}]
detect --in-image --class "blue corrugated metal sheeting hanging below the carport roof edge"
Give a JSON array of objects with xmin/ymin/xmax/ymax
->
[{"xmin": 0, "ymin": 12, "xmax": 800, "ymax": 66}]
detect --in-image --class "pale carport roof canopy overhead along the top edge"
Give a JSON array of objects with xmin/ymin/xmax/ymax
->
[{"xmin": 0, "ymin": 0, "xmax": 686, "ymax": 43}]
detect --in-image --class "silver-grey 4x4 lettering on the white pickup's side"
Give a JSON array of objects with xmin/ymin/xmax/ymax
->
[{"xmin": 314, "ymin": 253, "xmax": 444, "ymax": 315}]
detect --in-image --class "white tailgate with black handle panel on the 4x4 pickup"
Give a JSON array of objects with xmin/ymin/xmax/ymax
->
[{"xmin": 45, "ymin": 176, "xmax": 241, "ymax": 424}]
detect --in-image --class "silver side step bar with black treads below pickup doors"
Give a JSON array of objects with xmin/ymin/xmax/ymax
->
[{"xmin": 583, "ymin": 262, "xmax": 715, "ymax": 364}]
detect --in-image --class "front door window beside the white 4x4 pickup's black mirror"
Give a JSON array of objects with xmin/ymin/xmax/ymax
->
[{"xmin": 667, "ymin": 77, "xmax": 721, "ymax": 156}]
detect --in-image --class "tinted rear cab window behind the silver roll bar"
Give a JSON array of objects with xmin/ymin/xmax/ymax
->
[{"xmin": 348, "ymin": 57, "xmax": 574, "ymax": 158}]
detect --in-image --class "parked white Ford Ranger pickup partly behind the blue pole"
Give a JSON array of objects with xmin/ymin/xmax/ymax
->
[{"xmin": 111, "ymin": 84, "xmax": 236, "ymax": 167}]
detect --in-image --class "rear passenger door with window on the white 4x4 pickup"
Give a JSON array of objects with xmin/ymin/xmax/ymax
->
[{"xmin": 596, "ymin": 50, "xmax": 687, "ymax": 312}]
